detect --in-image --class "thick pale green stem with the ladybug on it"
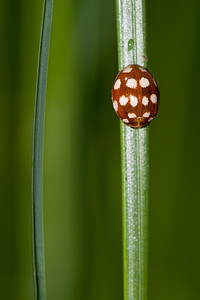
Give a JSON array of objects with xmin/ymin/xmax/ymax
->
[{"xmin": 117, "ymin": 0, "xmax": 149, "ymax": 300}]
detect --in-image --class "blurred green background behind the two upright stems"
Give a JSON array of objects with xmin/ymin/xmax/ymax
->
[{"xmin": 0, "ymin": 0, "xmax": 200, "ymax": 300}]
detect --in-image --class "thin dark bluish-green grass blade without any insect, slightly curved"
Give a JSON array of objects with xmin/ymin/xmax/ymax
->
[{"xmin": 32, "ymin": 0, "xmax": 53, "ymax": 300}]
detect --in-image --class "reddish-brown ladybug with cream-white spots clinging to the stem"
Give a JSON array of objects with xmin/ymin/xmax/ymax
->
[{"xmin": 112, "ymin": 65, "xmax": 159, "ymax": 128}]
